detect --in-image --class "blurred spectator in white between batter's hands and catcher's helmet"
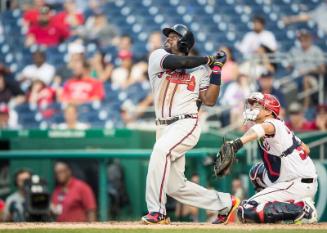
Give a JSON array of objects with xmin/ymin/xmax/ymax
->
[{"xmin": 220, "ymin": 74, "xmax": 250, "ymax": 128}]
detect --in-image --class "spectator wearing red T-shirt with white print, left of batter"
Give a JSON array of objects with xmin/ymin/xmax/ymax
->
[{"xmin": 58, "ymin": 61, "xmax": 105, "ymax": 105}]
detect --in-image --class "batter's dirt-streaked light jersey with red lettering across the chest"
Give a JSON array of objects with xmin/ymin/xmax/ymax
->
[{"xmin": 148, "ymin": 49, "xmax": 211, "ymax": 119}]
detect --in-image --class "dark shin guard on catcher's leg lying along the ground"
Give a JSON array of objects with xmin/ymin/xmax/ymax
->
[{"xmin": 237, "ymin": 201, "xmax": 303, "ymax": 223}]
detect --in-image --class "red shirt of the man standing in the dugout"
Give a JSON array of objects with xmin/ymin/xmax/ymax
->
[{"xmin": 52, "ymin": 177, "xmax": 96, "ymax": 222}]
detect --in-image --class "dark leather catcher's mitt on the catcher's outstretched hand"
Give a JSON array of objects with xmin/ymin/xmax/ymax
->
[{"xmin": 214, "ymin": 142, "xmax": 236, "ymax": 177}]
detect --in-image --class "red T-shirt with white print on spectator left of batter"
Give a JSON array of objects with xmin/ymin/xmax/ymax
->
[{"xmin": 61, "ymin": 77, "xmax": 104, "ymax": 104}]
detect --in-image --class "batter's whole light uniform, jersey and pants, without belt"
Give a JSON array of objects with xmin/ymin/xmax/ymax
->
[{"xmin": 146, "ymin": 49, "xmax": 231, "ymax": 214}]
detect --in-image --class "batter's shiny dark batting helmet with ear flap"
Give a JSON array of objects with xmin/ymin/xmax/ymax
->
[{"xmin": 162, "ymin": 24, "xmax": 194, "ymax": 54}]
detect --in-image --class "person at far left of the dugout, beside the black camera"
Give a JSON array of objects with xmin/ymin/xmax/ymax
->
[{"xmin": 4, "ymin": 169, "xmax": 32, "ymax": 222}]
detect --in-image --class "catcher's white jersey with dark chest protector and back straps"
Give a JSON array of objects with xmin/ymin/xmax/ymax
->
[{"xmin": 259, "ymin": 119, "xmax": 317, "ymax": 183}]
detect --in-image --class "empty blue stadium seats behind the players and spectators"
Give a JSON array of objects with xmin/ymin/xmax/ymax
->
[{"xmin": 0, "ymin": 0, "xmax": 327, "ymax": 128}]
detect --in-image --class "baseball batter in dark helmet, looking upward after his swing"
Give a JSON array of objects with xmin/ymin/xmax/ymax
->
[{"xmin": 142, "ymin": 24, "xmax": 237, "ymax": 224}]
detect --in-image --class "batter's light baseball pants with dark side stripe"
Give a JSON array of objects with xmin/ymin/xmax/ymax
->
[{"xmin": 146, "ymin": 118, "xmax": 231, "ymax": 214}]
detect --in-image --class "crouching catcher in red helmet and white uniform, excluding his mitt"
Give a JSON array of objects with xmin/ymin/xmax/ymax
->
[{"xmin": 220, "ymin": 92, "xmax": 317, "ymax": 223}]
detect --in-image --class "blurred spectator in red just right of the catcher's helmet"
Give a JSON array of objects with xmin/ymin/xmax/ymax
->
[{"xmin": 286, "ymin": 102, "xmax": 317, "ymax": 131}]
